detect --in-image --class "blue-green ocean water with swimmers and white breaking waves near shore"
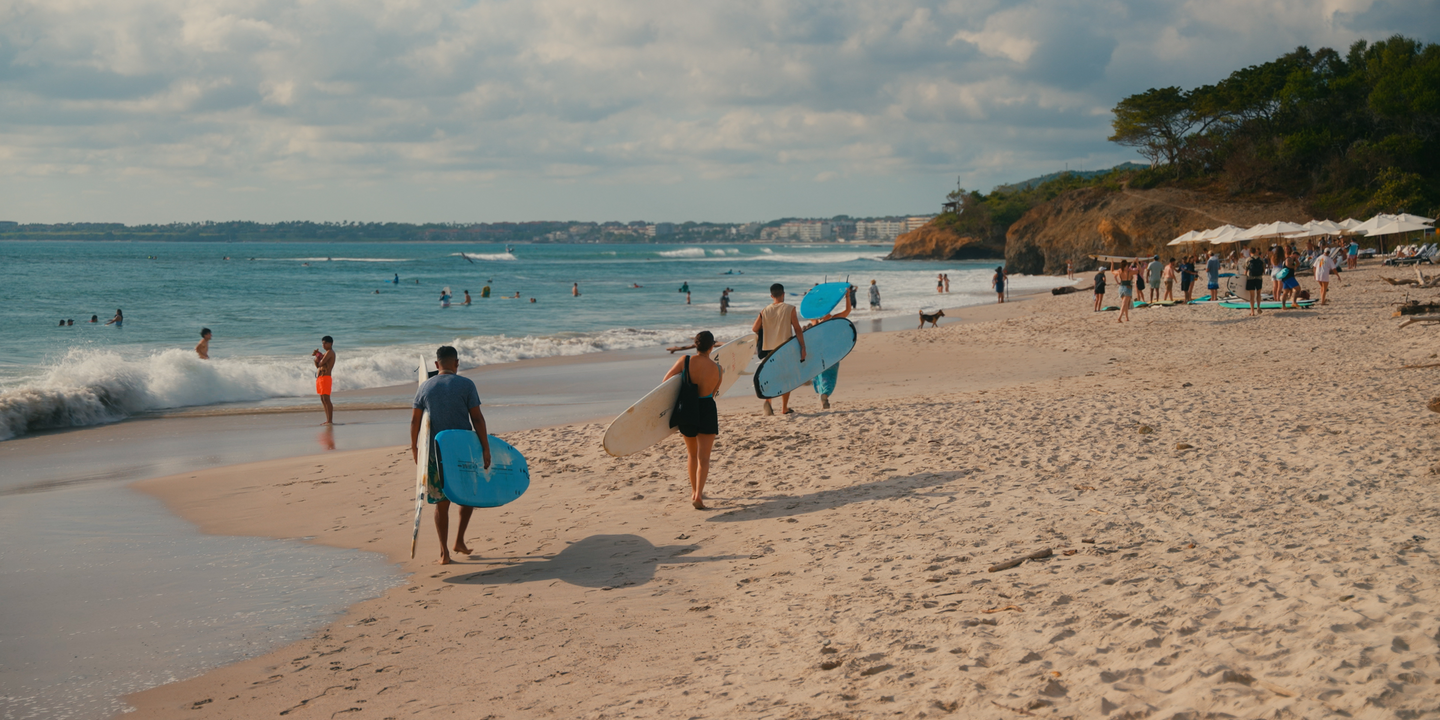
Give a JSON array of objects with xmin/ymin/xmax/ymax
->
[{"xmin": 0, "ymin": 242, "xmax": 1064, "ymax": 439}]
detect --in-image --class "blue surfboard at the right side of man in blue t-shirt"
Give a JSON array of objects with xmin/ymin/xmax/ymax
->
[{"xmin": 435, "ymin": 431, "xmax": 530, "ymax": 507}]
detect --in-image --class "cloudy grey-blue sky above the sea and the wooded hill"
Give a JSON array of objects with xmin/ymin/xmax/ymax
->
[{"xmin": 0, "ymin": 0, "xmax": 1422, "ymax": 223}]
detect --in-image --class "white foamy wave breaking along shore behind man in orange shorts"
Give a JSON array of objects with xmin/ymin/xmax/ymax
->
[{"xmin": 0, "ymin": 327, "xmax": 744, "ymax": 441}]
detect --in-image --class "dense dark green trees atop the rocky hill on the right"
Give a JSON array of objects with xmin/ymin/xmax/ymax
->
[{"xmin": 1110, "ymin": 35, "xmax": 1440, "ymax": 216}]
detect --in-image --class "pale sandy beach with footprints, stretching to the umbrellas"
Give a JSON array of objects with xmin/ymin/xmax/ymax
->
[{"xmin": 127, "ymin": 264, "xmax": 1440, "ymax": 719}]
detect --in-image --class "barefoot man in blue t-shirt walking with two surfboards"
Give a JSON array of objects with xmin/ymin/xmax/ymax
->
[{"xmin": 410, "ymin": 346, "xmax": 490, "ymax": 564}]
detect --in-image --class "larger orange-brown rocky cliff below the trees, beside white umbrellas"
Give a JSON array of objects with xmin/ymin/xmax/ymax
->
[{"xmin": 1008, "ymin": 187, "xmax": 1312, "ymax": 275}]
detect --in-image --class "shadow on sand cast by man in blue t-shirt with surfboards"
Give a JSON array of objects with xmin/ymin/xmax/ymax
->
[{"xmin": 445, "ymin": 534, "xmax": 744, "ymax": 588}]
